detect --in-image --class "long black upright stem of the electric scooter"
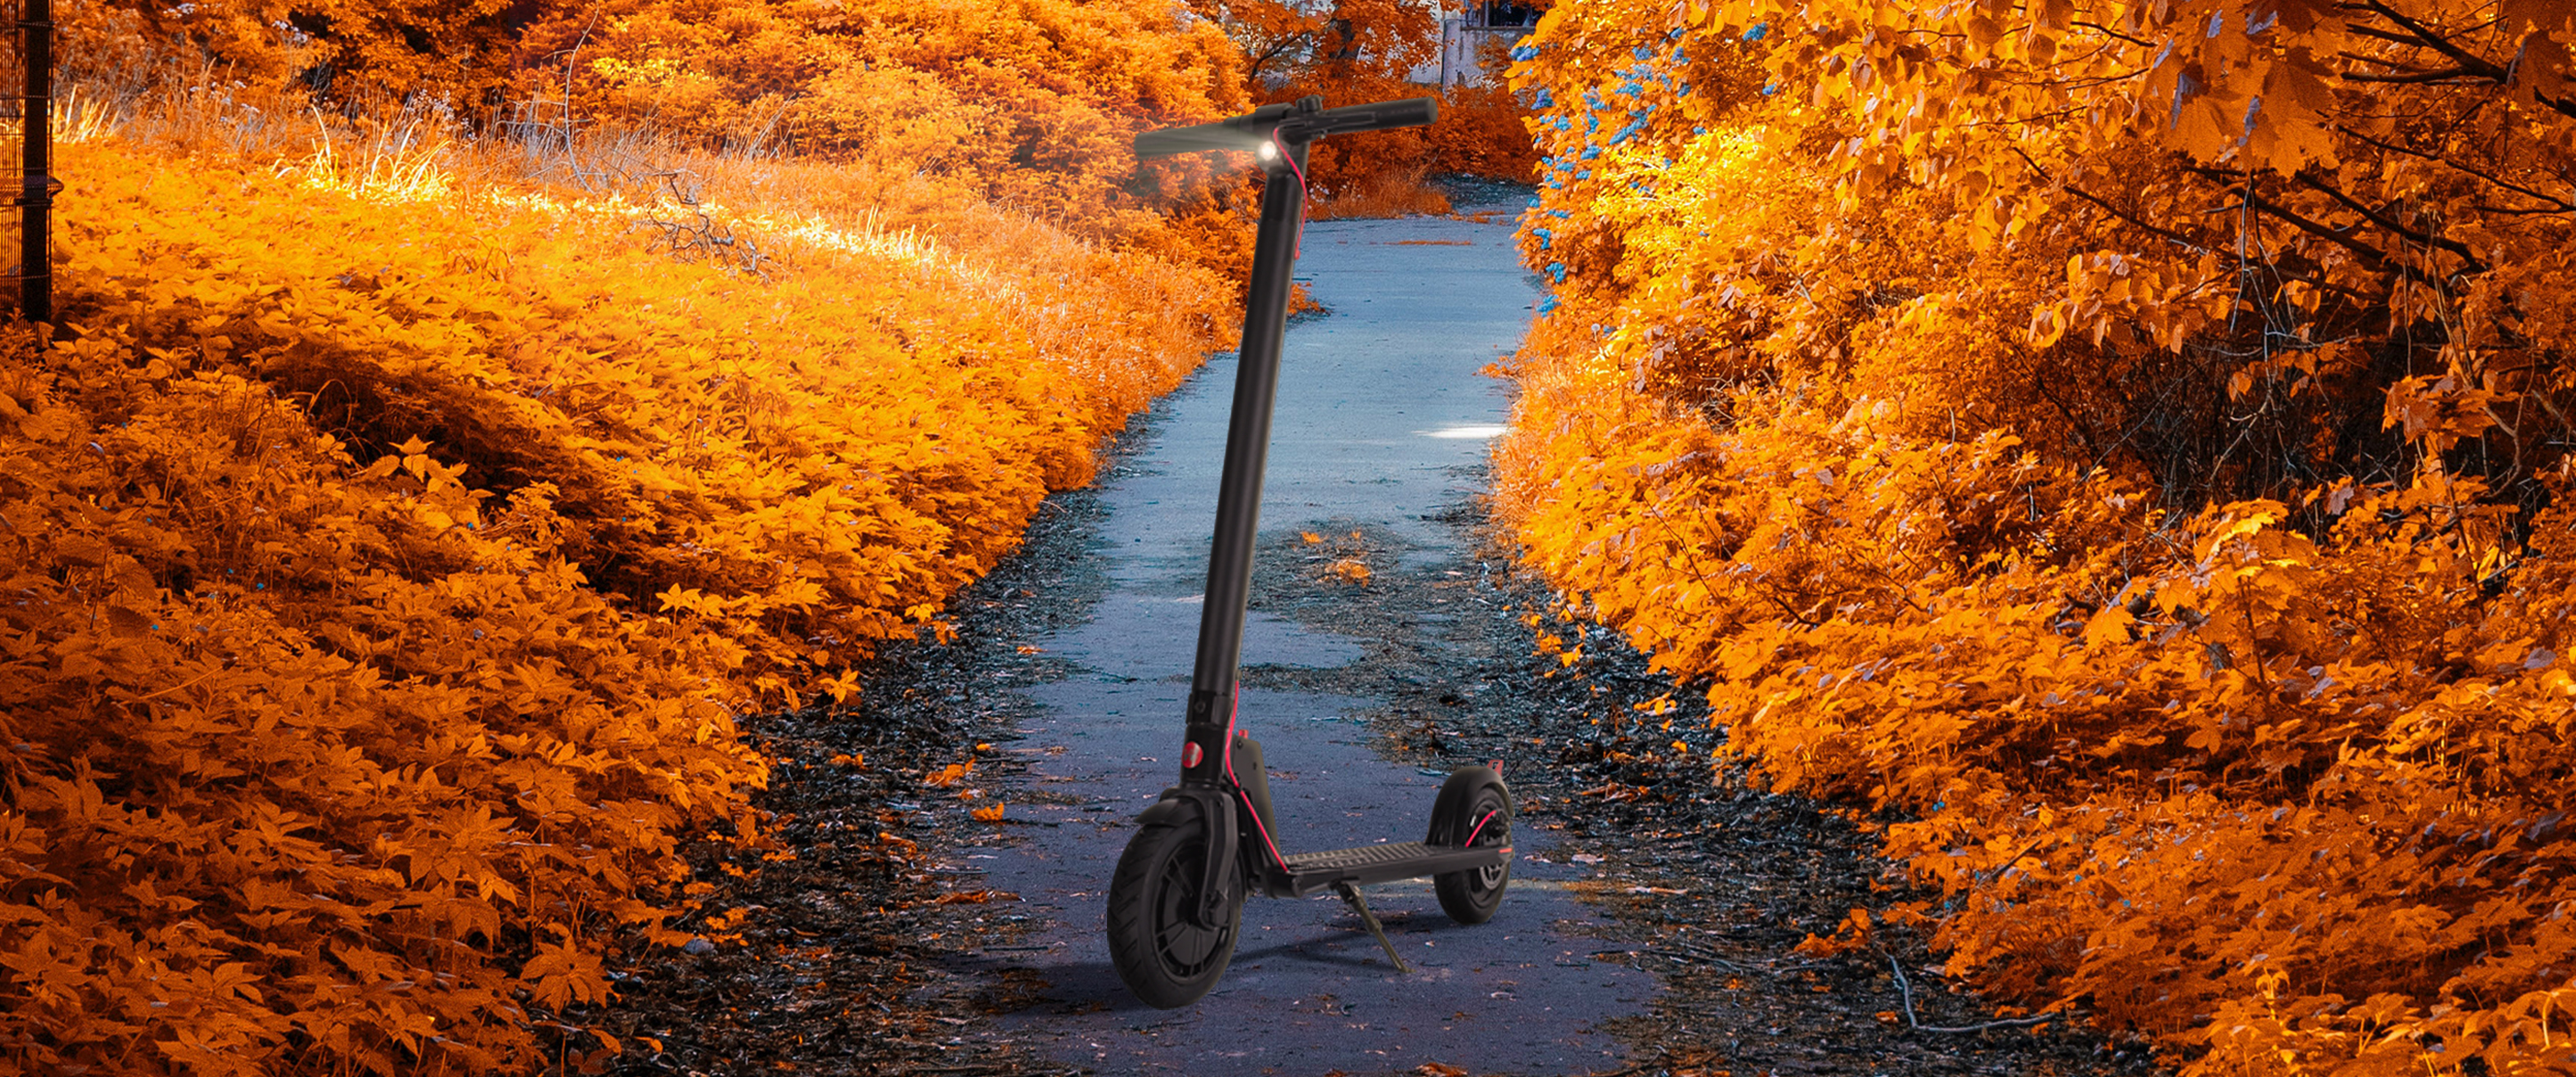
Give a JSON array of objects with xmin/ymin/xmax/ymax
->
[{"xmin": 1180, "ymin": 129, "xmax": 1311, "ymax": 785}]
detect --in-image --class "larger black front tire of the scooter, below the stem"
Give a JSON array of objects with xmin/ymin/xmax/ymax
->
[{"xmin": 1108, "ymin": 819, "xmax": 1244, "ymax": 1010}]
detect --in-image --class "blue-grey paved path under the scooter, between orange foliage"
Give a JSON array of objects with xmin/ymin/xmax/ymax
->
[{"xmin": 956, "ymin": 203, "xmax": 1659, "ymax": 1077}]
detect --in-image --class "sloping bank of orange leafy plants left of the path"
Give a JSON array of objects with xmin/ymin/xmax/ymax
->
[{"xmin": 0, "ymin": 42, "xmax": 1229, "ymax": 1072}]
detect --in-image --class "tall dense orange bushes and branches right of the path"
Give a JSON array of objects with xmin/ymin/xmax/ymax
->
[{"xmin": 1497, "ymin": 0, "xmax": 2576, "ymax": 1074}]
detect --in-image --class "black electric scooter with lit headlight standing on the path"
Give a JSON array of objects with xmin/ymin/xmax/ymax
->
[{"xmin": 1108, "ymin": 98, "xmax": 1512, "ymax": 1010}]
